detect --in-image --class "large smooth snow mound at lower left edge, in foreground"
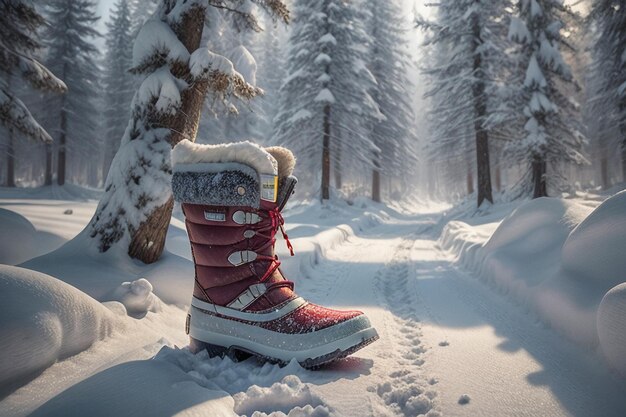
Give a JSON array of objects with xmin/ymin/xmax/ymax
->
[{"xmin": 0, "ymin": 265, "xmax": 123, "ymax": 396}]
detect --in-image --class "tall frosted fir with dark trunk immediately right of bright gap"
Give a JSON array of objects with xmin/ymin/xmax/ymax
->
[{"xmin": 417, "ymin": 0, "xmax": 509, "ymax": 206}]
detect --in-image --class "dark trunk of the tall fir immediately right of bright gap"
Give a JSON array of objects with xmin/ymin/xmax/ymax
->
[{"xmin": 472, "ymin": 12, "xmax": 493, "ymax": 207}]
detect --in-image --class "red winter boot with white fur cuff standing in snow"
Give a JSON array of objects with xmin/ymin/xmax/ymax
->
[{"xmin": 172, "ymin": 140, "xmax": 378, "ymax": 368}]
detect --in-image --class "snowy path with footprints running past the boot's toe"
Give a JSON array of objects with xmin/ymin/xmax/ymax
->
[{"xmin": 292, "ymin": 213, "xmax": 626, "ymax": 417}]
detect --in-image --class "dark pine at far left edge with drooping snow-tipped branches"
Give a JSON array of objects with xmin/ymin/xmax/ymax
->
[{"xmin": 0, "ymin": 0, "xmax": 66, "ymax": 186}]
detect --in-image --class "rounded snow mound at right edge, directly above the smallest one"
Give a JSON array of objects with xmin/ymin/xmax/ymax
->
[{"xmin": 563, "ymin": 191, "xmax": 626, "ymax": 291}]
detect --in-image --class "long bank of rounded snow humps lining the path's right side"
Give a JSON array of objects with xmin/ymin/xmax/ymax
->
[{"xmin": 440, "ymin": 192, "xmax": 626, "ymax": 372}]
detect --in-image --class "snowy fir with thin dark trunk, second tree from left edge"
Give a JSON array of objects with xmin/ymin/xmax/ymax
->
[{"xmin": 43, "ymin": 0, "xmax": 100, "ymax": 185}]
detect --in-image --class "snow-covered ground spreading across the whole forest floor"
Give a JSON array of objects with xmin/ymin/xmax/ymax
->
[{"xmin": 0, "ymin": 188, "xmax": 626, "ymax": 417}]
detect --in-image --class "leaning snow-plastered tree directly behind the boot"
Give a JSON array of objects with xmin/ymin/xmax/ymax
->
[{"xmin": 86, "ymin": 0, "xmax": 289, "ymax": 263}]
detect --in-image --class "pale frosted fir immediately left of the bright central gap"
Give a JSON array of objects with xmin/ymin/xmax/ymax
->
[{"xmin": 360, "ymin": 0, "xmax": 417, "ymax": 201}]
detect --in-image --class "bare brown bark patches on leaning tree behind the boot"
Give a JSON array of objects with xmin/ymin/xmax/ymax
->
[{"xmin": 128, "ymin": 2, "xmax": 209, "ymax": 264}]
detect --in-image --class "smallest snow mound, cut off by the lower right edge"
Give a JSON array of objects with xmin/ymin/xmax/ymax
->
[{"xmin": 597, "ymin": 282, "xmax": 626, "ymax": 375}]
